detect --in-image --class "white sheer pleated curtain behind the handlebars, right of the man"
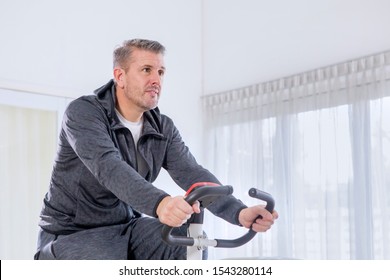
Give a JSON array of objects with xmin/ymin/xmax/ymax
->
[{"xmin": 203, "ymin": 52, "xmax": 390, "ymax": 259}]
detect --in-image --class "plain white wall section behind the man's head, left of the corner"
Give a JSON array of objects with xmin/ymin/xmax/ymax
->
[{"xmin": 0, "ymin": 0, "xmax": 206, "ymax": 194}]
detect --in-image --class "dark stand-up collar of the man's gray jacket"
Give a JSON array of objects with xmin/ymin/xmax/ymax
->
[{"xmin": 94, "ymin": 79, "xmax": 162, "ymax": 134}]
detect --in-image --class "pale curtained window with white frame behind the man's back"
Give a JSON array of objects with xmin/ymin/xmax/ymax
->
[{"xmin": 0, "ymin": 87, "xmax": 70, "ymax": 260}]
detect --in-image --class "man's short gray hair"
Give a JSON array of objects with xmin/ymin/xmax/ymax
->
[{"xmin": 114, "ymin": 39, "xmax": 165, "ymax": 71}]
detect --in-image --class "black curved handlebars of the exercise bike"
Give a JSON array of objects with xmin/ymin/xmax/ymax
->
[{"xmin": 162, "ymin": 186, "xmax": 275, "ymax": 248}]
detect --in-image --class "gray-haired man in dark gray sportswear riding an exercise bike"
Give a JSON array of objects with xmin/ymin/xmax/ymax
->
[{"xmin": 35, "ymin": 39, "xmax": 277, "ymax": 259}]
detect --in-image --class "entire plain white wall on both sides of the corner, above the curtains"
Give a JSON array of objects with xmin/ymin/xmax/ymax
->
[{"xmin": 0, "ymin": 0, "xmax": 390, "ymax": 186}]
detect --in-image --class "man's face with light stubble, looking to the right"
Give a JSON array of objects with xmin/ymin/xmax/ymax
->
[{"xmin": 123, "ymin": 49, "xmax": 165, "ymax": 112}]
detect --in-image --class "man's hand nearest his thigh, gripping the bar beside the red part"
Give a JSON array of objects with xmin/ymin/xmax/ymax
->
[{"xmin": 156, "ymin": 196, "xmax": 200, "ymax": 227}]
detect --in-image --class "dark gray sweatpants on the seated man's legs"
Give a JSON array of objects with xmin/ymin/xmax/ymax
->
[{"xmin": 34, "ymin": 217, "xmax": 192, "ymax": 260}]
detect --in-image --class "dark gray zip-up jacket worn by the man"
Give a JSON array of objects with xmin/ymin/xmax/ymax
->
[{"xmin": 39, "ymin": 80, "xmax": 246, "ymax": 234}]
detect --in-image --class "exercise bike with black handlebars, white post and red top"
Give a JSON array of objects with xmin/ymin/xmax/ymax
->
[{"xmin": 162, "ymin": 182, "xmax": 275, "ymax": 260}]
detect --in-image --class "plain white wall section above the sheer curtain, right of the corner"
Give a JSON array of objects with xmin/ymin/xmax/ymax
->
[{"xmin": 203, "ymin": 0, "xmax": 390, "ymax": 94}]
